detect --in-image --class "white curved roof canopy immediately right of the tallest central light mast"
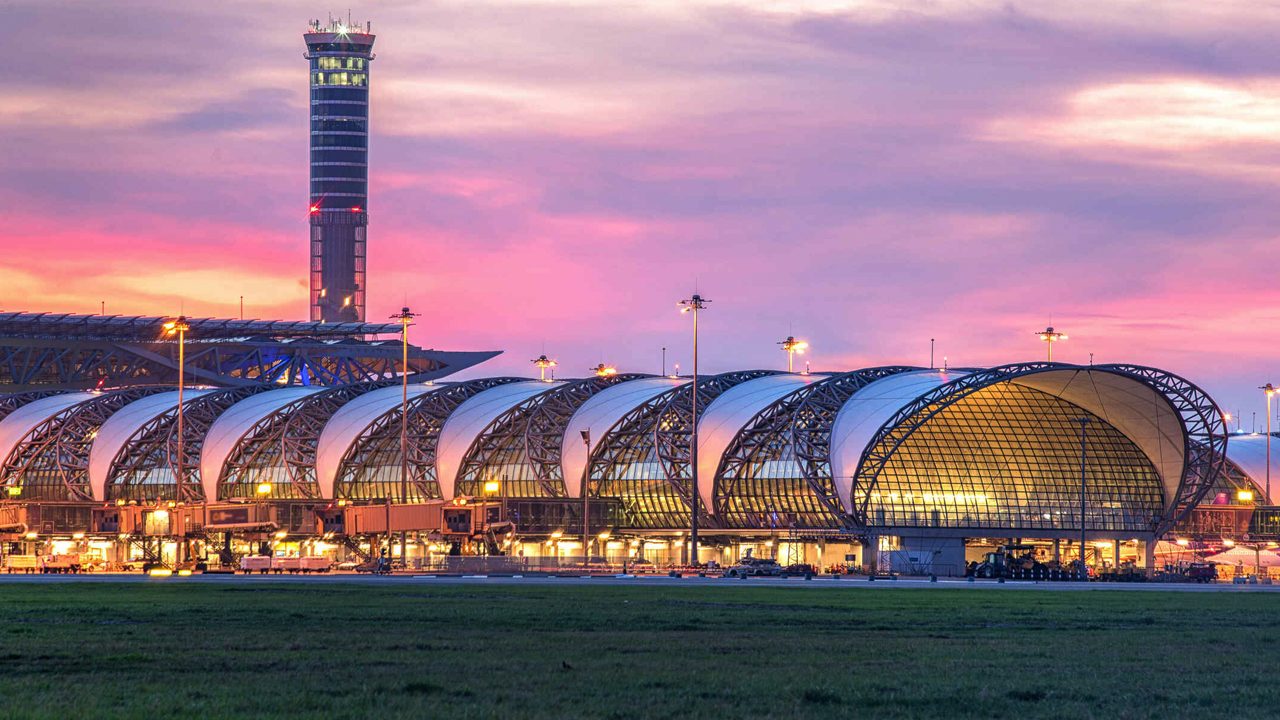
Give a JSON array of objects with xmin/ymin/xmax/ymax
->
[{"xmin": 698, "ymin": 374, "xmax": 828, "ymax": 514}]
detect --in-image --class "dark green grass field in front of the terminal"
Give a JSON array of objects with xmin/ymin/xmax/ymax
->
[{"xmin": 0, "ymin": 580, "xmax": 1280, "ymax": 719}]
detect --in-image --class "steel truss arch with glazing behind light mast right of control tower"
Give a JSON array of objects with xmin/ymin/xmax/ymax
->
[{"xmin": 333, "ymin": 377, "xmax": 526, "ymax": 502}]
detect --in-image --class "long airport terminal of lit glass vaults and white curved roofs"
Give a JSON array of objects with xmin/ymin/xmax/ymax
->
[{"xmin": 0, "ymin": 319, "xmax": 1265, "ymax": 573}]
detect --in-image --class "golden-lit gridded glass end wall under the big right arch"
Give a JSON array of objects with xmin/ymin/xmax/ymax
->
[{"xmin": 864, "ymin": 383, "xmax": 1164, "ymax": 532}]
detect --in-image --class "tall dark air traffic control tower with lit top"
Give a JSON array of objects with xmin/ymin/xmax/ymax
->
[{"xmin": 303, "ymin": 18, "xmax": 374, "ymax": 323}]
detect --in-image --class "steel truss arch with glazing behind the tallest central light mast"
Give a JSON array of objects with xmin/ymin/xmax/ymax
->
[{"xmin": 584, "ymin": 370, "xmax": 778, "ymax": 528}]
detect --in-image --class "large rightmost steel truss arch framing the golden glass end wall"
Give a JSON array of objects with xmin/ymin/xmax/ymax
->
[{"xmin": 851, "ymin": 363, "xmax": 1226, "ymax": 536}]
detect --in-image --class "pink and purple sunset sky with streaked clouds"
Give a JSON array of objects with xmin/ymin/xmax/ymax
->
[{"xmin": 0, "ymin": 0, "xmax": 1280, "ymax": 415}]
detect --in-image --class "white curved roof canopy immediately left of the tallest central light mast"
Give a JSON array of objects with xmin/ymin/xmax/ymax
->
[{"xmin": 561, "ymin": 378, "xmax": 689, "ymax": 497}]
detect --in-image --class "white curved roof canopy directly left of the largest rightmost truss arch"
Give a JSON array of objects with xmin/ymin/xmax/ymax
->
[{"xmin": 831, "ymin": 370, "xmax": 964, "ymax": 509}]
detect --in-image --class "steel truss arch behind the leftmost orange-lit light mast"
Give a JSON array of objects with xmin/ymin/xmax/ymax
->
[{"xmin": 105, "ymin": 386, "xmax": 275, "ymax": 502}]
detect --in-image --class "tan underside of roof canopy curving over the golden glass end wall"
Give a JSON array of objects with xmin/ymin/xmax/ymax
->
[{"xmin": 1012, "ymin": 368, "xmax": 1182, "ymax": 507}]
